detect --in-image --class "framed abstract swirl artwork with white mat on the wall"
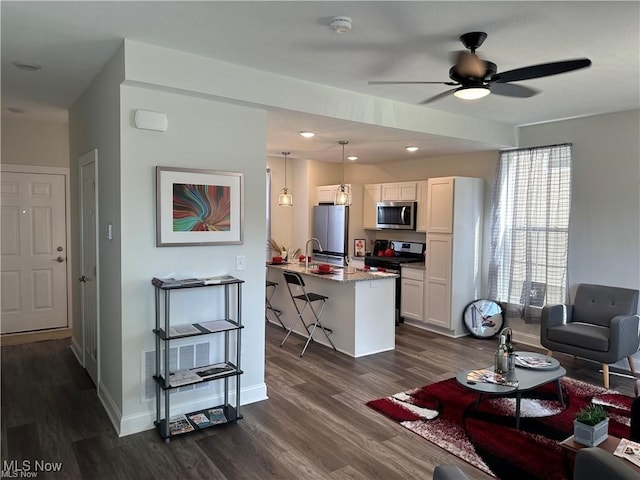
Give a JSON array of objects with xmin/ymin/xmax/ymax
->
[{"xmin": 156, "ymin": 166, "xmax": 244, "ymax": 247}]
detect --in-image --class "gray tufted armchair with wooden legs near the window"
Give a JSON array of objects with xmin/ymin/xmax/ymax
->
[{"xmin": 540, "ymin": 283, "xmax": 640, "ymax": 388}]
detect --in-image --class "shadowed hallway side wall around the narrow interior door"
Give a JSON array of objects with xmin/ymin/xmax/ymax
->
[{"xmin": 69, "ymin": 43, "xmax": 124, "ymax": 416}]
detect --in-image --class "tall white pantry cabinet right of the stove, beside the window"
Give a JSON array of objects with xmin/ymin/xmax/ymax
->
[{"xmin": 424, "ymin": 177, "xmax": 485, "ymax": 337}]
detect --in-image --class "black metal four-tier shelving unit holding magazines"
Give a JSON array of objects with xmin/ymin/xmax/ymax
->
[{"xmin": 151, "ymin": 275, "xmax": 244, "ymax": 442}]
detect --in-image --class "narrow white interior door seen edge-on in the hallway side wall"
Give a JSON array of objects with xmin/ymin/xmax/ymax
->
[{"xmin": 79, "ymin": 150, "xmax": 98, "ymax": 386}]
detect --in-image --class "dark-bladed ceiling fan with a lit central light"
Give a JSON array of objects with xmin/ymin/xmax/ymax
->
[{"xmin": 369, "ymin": 32, "xmax": 591, "ymax": 104}]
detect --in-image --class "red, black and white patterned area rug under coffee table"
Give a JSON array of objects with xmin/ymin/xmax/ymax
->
[{"xmin": 367, "ymin": 378, "xmax": 633, "ymax": 480}]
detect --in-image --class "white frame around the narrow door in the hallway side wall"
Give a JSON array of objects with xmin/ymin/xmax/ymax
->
[{"xmin": 78, "ymin": 152, "xmax": 100, "ymax": 393}]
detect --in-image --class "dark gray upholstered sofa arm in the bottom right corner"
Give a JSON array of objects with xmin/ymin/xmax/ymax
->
[{"xmin": 573, "ymin": 447, "xmax": 638, "ymax": 480}]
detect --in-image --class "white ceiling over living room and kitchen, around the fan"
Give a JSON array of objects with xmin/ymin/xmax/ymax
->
[{"xmin": 1, "ymin": 1, "xmax": 640, "ymax": 163}]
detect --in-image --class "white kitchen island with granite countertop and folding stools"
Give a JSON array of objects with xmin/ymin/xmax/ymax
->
[{"xmin": 267, "ymin": 262, "xmax": 398, "ymax": 357}]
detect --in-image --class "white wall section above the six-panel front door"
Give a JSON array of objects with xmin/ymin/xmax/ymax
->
[{"xmin": 0, "ymin": 113, "xmax": 69, "ymax": 168}]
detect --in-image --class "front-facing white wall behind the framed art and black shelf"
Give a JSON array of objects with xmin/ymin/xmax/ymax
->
[{"xmin": 121, "ymin": 86, "xmax": 266, "ymax": 430}]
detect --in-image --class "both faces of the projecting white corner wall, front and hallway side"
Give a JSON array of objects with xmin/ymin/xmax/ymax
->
[{"xmin": 69, "ymin": 40, "xmax": 266, "ymax": 435}]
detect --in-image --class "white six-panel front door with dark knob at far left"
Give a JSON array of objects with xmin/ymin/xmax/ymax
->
[{"xmin": 0, "ymin": 171, "xmax": 68, "ymax": 334}]
